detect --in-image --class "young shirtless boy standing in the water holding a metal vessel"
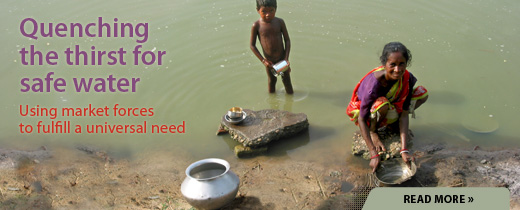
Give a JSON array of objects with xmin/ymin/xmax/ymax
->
[{"xmin": 250, "ymin": 0, "xmax": 293, "ymax": 94}]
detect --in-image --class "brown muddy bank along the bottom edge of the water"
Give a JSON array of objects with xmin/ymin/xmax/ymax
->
[{"xmin": 0, "ymin": 145, "xmax": 520, "ymax": 209}]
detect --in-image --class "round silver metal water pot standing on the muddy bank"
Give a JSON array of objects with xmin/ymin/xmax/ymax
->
[{"xmin": 181, "ymin": 158, "xmax": 240, "ymax": 209}]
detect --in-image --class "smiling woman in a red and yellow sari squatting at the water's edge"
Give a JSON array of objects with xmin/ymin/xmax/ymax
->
[{"xmin": 347, "ymin": 42, "xmax": 428, "ymax": 172}]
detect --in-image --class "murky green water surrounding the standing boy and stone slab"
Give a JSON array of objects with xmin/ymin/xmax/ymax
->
[{"xmin": 0, "ymin": 0, "xmax": 520, "ymax": 162}]
